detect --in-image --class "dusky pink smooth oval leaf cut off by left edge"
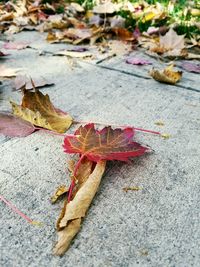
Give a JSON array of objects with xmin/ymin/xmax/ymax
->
[{"xmin": 0, "ymin": 112, "xmax": 35, "ymax": 137}]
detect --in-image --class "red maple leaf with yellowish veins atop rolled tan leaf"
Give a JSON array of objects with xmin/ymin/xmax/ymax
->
[{"xmin": 63, "ymin": 123, "xmax": 149, "ymax": 162}]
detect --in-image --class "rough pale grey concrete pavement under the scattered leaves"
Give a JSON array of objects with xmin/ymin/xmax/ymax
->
[{"xmin": 0, "ymin": 32, "xmax": 200, "ymax": 267}]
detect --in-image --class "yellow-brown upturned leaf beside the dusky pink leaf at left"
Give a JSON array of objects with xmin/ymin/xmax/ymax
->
[{"xmin": 11, "ymin": 89, "xmax": 72, "ymax": 133}]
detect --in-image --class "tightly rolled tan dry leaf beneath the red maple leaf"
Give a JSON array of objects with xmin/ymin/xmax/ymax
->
[{"xmin": 54, "ymin": 160, "xmax": 106, "ymax": 255}]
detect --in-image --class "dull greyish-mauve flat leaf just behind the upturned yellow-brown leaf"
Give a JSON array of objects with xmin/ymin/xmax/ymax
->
[{"xmin": 13, "ymin": 75, "xmax": 54, "ymax": 90}]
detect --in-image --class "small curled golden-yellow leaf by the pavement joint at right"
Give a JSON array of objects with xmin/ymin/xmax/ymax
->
[{"xmin": 149, "ymin": 65, "xmax": 182, "ymax": 84}]
